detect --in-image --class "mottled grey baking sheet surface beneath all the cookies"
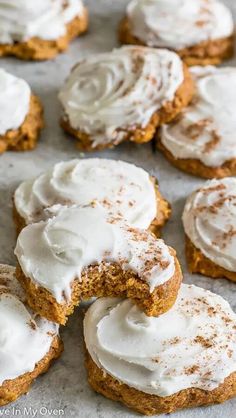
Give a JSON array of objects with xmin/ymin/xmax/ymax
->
[{"xmin": 0, "ymin": 0, "xmax": 236, "ymax": 418}]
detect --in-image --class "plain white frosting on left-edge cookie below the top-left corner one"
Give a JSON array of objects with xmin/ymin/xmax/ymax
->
[{"xmin": 0, "ymin": 68, "xmax": 31, "ymax": 135}]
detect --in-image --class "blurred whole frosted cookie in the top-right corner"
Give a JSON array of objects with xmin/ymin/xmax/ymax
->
[{"xmin": 119, "ymin": 0, "xmax": 234, "ymax": 65}]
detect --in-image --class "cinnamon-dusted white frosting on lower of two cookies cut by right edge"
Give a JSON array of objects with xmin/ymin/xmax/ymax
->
[{"xmin": 183, "ymin": 178, "xmax": 236, "ymax": 272}]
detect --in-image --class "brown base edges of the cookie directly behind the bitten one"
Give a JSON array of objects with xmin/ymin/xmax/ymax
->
[{"xmin": 13, "ymin": 177, "xmax": 171, "ymax": 238}]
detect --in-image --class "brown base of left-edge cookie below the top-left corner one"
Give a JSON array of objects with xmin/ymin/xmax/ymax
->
[{"xmin": 0, "ymin": 95, "xmax": 44, "ymax": 154}]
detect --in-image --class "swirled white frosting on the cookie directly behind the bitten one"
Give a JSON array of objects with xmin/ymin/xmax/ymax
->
[{"xmin": 14, "ymin": 158, "xmax": 158, "ymax": 229}]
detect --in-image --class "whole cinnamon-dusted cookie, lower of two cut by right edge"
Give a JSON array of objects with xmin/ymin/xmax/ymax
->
[{"xmin": 183, "ymin": 178, "xmax": 236, "ymax": 281}]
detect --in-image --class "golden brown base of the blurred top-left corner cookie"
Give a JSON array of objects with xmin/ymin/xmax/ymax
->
[{"xmin": 0, "ymin": 9, "xmax": 88, "ymax": 61}]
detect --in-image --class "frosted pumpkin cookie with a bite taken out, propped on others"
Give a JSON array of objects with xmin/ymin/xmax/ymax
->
[{"xmin": 15, "ymin": 205, "xmax": 182, "ymax": 324}]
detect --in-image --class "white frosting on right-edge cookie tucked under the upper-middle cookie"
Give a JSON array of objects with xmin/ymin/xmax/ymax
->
[{"xmin": 161, "ymin": 67, "xmax": 236, "ymax": 167}]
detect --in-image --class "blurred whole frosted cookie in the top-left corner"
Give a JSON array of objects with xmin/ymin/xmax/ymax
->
[{"xmin": 0, "ymin": 0, "xmax": 88, "ymax": 60}]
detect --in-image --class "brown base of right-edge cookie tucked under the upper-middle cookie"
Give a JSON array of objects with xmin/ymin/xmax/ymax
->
[{"xmin": 157, "ymin": 139, "xmax": 236, "ymax": 179}]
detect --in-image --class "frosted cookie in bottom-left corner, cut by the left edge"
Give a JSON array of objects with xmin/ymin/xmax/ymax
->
[{"xmin": 0, "ymin": 264, "xmax": 63, "ymax": 406}]
